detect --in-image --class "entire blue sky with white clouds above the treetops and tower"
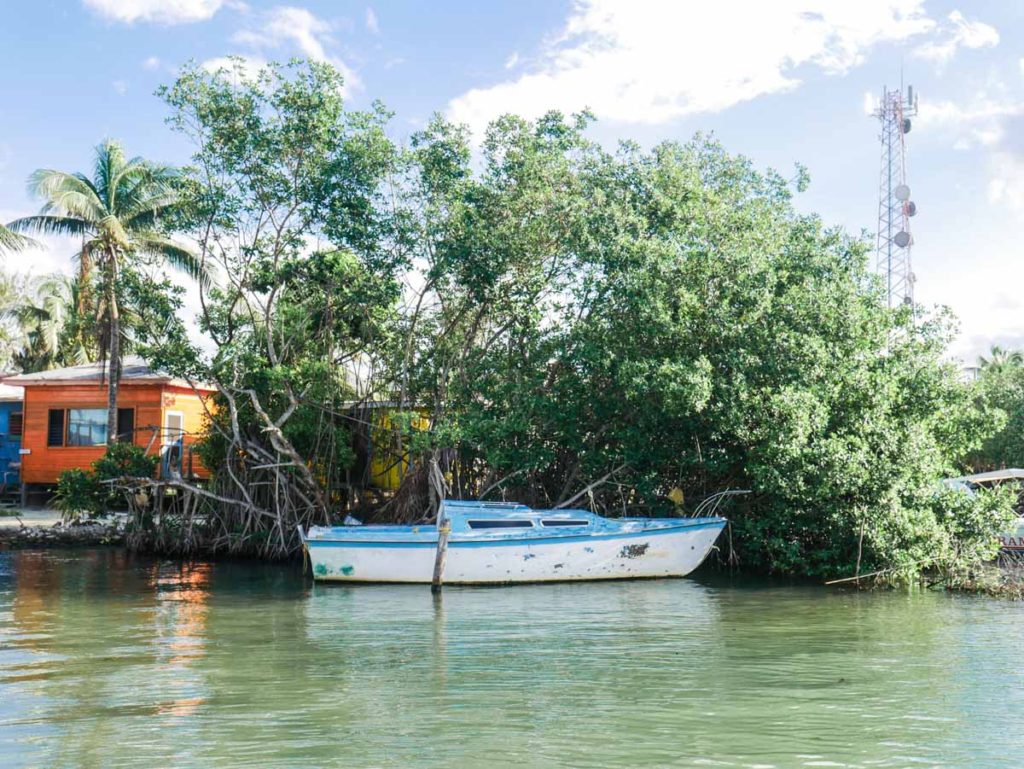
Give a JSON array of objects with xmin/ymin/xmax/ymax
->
[{"xmin": 0, "ymin": 0, "xmax": 1024, "ymax": 362}]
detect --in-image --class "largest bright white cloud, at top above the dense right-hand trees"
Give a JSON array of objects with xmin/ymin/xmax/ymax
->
[{"xmin": 449, "ymin": 0, "xmax": 935, "ymax": 137}]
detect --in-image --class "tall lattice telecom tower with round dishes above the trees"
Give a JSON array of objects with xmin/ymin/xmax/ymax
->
[{"xmin": 874, "ymin": 83, "xmax": 918, "ymax": 307}]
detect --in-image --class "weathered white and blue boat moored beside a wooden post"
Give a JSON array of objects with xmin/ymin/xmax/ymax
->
[{"xmin": 301, "ymin": 500, "xmax": 726, "ymax": 585}]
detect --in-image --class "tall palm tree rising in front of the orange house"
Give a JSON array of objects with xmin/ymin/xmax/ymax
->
[{"xmin": 7, "ymin": 139, "xmax": 206, "ymax": 436}]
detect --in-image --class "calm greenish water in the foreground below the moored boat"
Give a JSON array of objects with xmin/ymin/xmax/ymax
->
[{"xmin": 0, "ymin": 550, "xmax": 1024, "ymax": 769}]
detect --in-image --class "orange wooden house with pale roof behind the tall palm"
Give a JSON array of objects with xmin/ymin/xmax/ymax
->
[{"xmin": 2, "ymin": 357, "xmax": 215, "ymax": 499}]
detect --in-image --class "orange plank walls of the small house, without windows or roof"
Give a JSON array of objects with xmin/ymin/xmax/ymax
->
[{"xmin": 22, "ymin": 382, "xmax": 215, "ymax": 483}]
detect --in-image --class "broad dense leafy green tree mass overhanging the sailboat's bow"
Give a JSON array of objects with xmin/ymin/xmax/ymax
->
[{"xmin": 395, "ymin": 115, "xmax": 1001, "ymax": 575}]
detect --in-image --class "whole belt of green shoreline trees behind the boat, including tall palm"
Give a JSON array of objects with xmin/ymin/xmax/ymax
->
[{"xmin": 0, "ymin": 61, "xmax": 1011, "ymax": 576}]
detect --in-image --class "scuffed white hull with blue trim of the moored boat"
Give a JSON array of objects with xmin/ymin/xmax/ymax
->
[{"xmin": 306, "ymin": 519, "xmax": 725, "ymax": 585}]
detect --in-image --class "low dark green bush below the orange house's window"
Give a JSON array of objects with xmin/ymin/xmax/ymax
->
[{"xmin": 54, "ymin": 442, "xmax": 158, "ymax": 521}]
